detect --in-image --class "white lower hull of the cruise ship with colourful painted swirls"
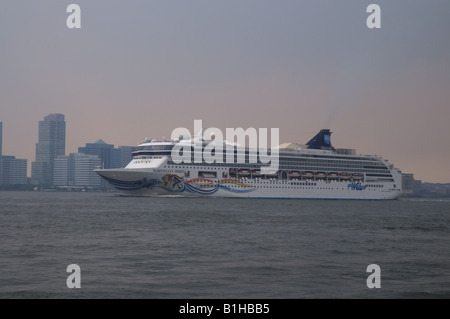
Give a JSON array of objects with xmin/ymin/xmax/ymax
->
[{"xmin": 97, "ymin": 168, "xmax": 401, "ymax": 200}]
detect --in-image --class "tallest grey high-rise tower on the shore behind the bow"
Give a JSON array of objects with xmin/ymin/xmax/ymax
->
[{"xmin": 31, "ymin": 114, "xmax": 66, "ymax": 185}]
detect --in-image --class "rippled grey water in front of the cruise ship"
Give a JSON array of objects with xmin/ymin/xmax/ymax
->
[{"xmin": 0, "ymin": 192, "xmax": 450, "ymax": 299}]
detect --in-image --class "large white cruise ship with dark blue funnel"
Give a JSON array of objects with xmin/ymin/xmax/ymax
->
[{"xmin": 96, "ymin": 129, "xmax": 402, "ymax": 200}]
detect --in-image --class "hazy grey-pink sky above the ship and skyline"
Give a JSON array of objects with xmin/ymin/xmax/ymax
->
[{"xmin": 0, "ymin": 0, "xmax": 450, "ymax": 182}]
